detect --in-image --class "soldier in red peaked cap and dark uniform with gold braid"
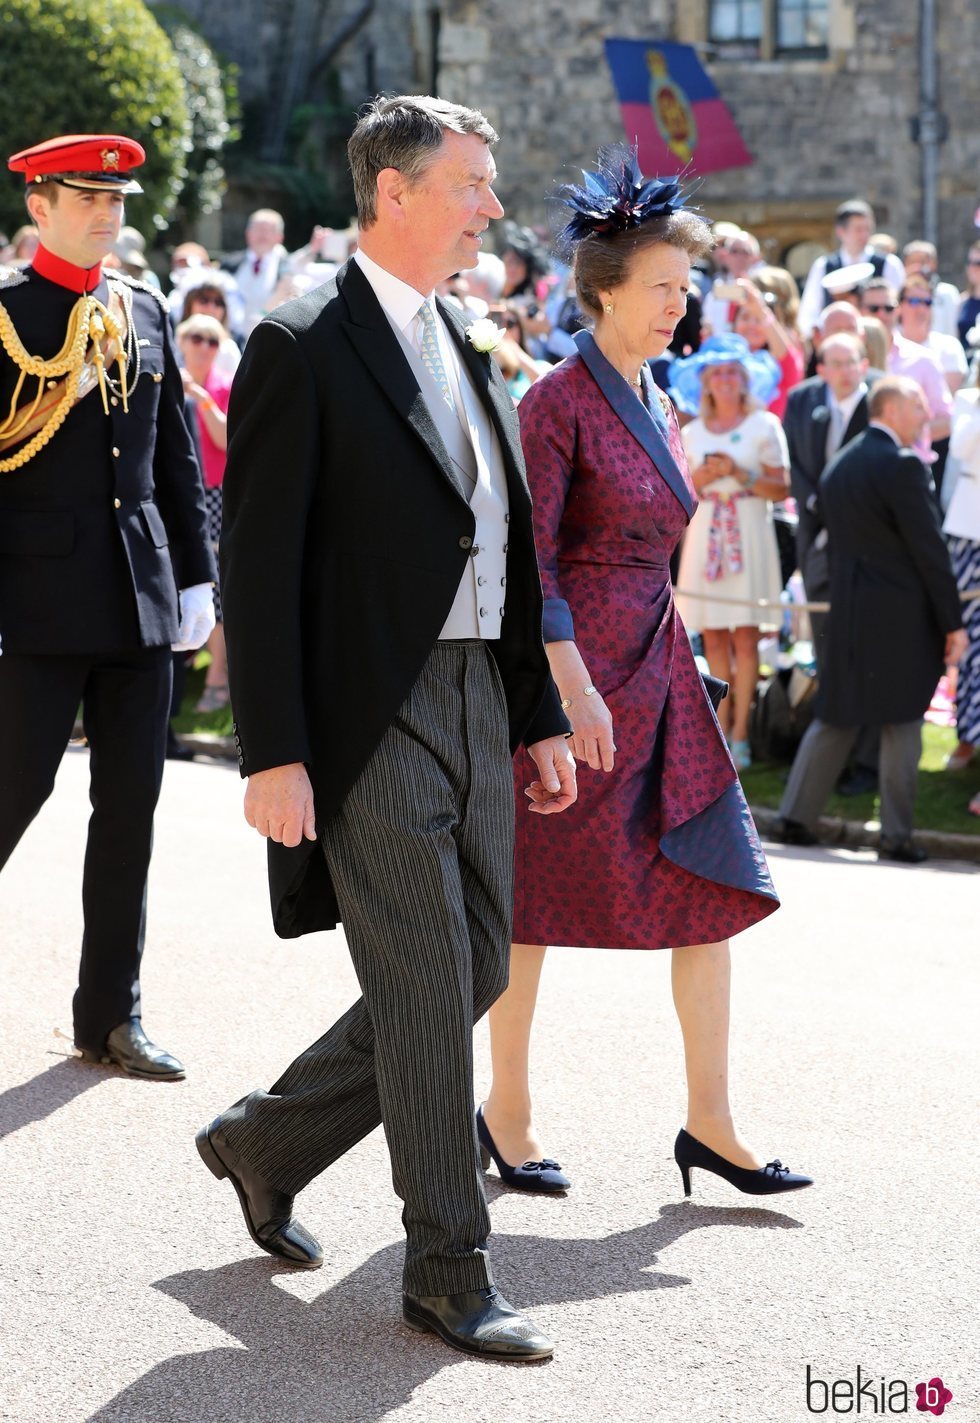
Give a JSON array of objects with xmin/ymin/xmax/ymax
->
[{"xmin": 0, "ymin": 134, "xmax": 215, "ymax": 1079}]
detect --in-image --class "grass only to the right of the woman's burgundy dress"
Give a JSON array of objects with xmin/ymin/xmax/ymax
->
[{"xmin": 741, "ymin": 721, "xmax": 980, "ymax": 835}]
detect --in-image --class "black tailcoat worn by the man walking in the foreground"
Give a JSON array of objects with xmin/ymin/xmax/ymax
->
[{"xmin": 220, "ymin": 262, "xmax": 568, "ymax": 938}]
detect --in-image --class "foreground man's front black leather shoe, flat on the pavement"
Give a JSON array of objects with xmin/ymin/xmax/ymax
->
[{"xmin": 401, "ymin": 1285, "xmax": 555, "ymax": 1363}]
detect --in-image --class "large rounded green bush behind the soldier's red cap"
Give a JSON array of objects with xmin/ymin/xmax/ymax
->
[{"xmin": 0, "ymin": 0, "xmax": 191, "ymax": 235}]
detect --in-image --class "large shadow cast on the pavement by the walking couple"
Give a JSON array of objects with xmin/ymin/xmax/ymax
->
[{"xmin": 88, "ymin": 1204, "xmax": 801, "ymax": 1423}]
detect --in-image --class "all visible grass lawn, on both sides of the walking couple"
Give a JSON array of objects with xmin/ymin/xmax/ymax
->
[{"xmin": 174, "ymin": 653, "xmax": 980, "ymax": 835}]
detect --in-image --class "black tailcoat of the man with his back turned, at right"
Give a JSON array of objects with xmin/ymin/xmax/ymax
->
[{"xmin": 819, "ymin": 425, "xmax": 963, "ymax": 726}]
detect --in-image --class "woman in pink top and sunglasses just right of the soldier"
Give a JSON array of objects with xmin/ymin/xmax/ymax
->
[{"xmin": 176, "ymin": 312, "xmax": 232, "ymax": 712}]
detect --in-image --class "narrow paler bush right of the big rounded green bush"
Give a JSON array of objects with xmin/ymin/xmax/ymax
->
[{"xmin": 154, "ymin": 6, "xmax": 242, "ymax": 223}]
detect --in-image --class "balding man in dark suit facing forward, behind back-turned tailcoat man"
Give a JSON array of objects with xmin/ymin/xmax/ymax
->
[{"xmin": 782, "ymin": 332, "xmax": 868, "ymax": 673}]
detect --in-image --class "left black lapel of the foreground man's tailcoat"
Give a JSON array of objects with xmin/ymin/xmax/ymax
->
[{"xmin": 337, "ymin": 259, "xmax": 465, "ymax": 499}]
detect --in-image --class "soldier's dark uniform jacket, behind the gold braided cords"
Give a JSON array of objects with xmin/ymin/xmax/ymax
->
[{"xmin": 0, "ymin": 268, "xmax": 216, "ymax": 655}]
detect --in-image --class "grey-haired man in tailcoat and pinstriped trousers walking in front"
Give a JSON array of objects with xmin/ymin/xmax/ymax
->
[{"xmin": 198, "ymin": 97, "xmax": 575, "ymax": 1360}]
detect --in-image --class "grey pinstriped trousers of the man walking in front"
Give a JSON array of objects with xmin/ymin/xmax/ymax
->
[{"xmin": 222, "ymin": 642, "xmax": 513, "ymax": 1295}]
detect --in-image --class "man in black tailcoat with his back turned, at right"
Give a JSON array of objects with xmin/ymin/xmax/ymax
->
[{"xmin": 774, "ymin": 376, "xmax": 966, "ymax": 864}]
